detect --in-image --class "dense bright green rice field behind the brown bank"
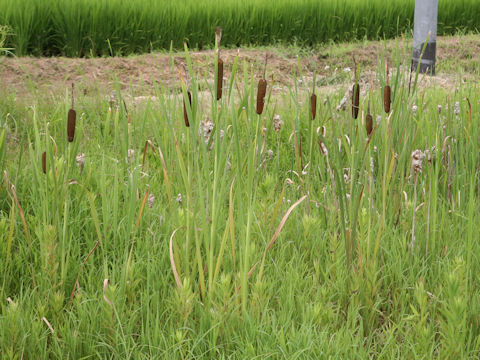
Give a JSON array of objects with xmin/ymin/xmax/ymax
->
[{"xmin": 0, "ymin": 0, "xmax": 480, "ymax": 56}]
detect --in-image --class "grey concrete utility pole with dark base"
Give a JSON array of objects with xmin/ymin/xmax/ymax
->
[{"xmin": 412, "ymin": 0, "xmax": 438, "ymax": 75}]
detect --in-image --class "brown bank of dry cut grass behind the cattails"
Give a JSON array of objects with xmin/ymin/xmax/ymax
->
[{"xmin": 0, "ymin": 35, "xmax": 480, "ymax": 102}]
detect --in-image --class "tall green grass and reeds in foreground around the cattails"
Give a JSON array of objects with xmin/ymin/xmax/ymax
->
[{"xmin": 0, "ymin": 41, "xmax": 480, "ymax": 359}]
